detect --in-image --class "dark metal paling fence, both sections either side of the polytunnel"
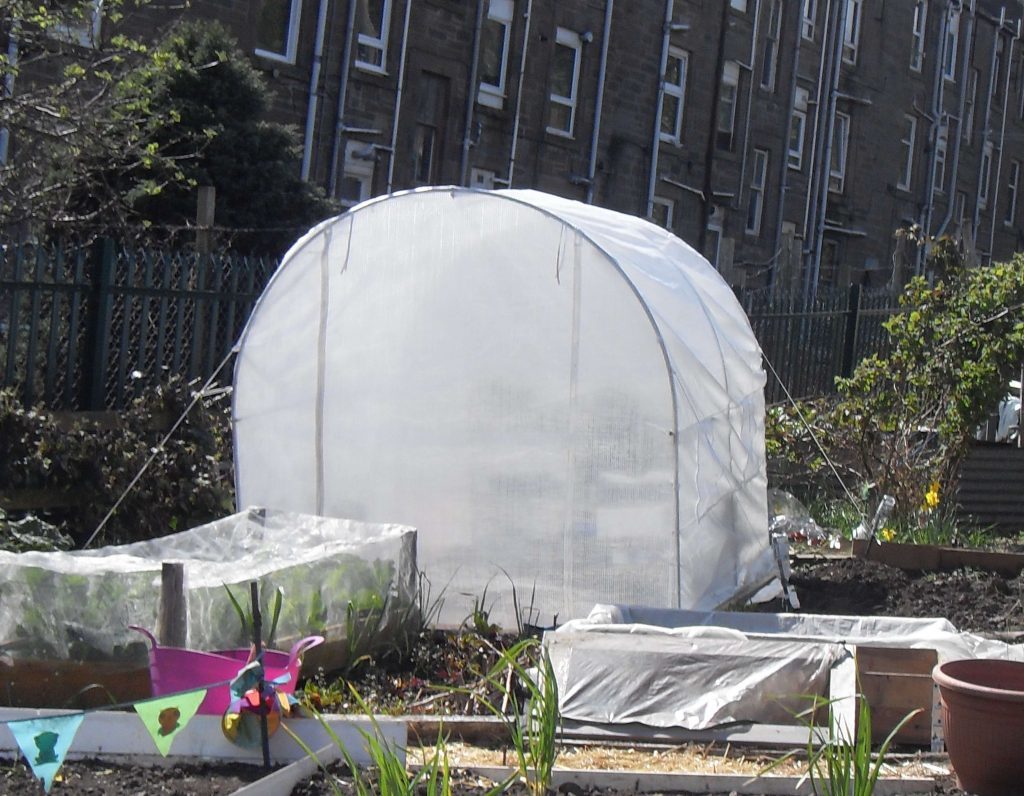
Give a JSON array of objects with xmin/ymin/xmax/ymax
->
[{"xmin": 0, "ymin": 240, "xmax": 897, "ymax": 410}]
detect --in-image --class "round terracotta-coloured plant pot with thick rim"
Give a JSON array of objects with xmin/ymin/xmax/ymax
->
[{"xmin": 932, "ymin": 660, "xmax": 1024, "ymax": 796}]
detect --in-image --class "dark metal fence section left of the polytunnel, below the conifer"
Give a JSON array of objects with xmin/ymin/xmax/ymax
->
[{"xmin": 0, "ymin": 240, "xmax": 276, "ymax": 410}]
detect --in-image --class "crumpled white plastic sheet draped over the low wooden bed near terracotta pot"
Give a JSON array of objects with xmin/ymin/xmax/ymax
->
[{"xmin": 544, "ymin": 604, "xmax": 1024, "ymax": 729}]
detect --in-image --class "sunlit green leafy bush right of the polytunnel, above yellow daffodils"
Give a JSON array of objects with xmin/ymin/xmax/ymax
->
[{"xmin": 766, "ymin": 239, "xmax": 1024, "ymax": 527}]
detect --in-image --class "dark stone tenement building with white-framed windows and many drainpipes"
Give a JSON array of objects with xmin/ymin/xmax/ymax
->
[{"xmin": 16, "ymin": 0, "xmax": 1024, "ymax": 289}]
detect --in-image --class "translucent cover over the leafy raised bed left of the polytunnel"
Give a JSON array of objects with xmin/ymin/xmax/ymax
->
[{"xmin": 0, "ymin": 509, "xmax": 416, "ymax": 660}]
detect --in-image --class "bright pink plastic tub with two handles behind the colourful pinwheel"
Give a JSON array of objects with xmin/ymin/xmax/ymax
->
[{"xmin": 129, "ymin": 625, "xmax": 324, "ymax": 716}]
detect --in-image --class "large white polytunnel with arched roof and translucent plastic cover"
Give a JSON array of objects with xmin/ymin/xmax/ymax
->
[{"xmin": 233, "ymin": 187, "xmax": 774, "ymax": 626}]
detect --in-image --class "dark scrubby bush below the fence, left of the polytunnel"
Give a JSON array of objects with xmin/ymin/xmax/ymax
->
[{"xmin": 0, "ymin": 379, "xmax": 234, "ymax": 544}]
